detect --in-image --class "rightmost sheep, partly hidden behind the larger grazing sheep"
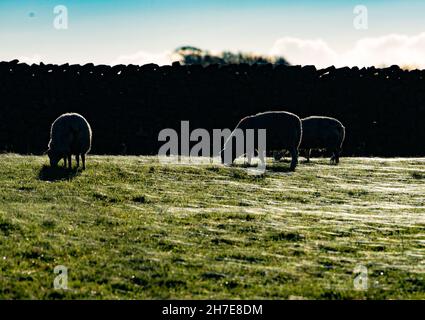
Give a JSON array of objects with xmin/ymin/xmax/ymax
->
[{"xmin": 300, "ymin": 116, "xmax": 345, "ymax": 164}]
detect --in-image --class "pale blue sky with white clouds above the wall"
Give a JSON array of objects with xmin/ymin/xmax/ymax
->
[{"xmin": 0, "ymin": 0, "xmax": 425, "ymax": 68}]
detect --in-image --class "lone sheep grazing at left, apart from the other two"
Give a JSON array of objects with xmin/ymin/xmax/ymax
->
[{"xmin": 47, "ymin": 113, "xmax": 92, "ymax": 169}]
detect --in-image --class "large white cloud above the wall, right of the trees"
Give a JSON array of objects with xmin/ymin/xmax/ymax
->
[{"xmin": 270, "ymin": 32, "xmax": 425, "ymax": 69}]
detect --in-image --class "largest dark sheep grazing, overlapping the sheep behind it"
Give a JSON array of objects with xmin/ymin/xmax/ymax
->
[{"xmin": 220, "ymin": 111, "xmax": 302, "ymax": 171}]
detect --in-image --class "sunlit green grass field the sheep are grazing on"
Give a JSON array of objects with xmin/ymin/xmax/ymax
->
[{"xmin": 0, "ymin": 155, "xmax": 425, "ymax": 299}]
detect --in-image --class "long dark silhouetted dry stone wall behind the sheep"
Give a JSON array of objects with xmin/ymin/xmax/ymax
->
[{"xmin": 0, "ymin": 60, "xmax": 425, "ymax": 156}]
